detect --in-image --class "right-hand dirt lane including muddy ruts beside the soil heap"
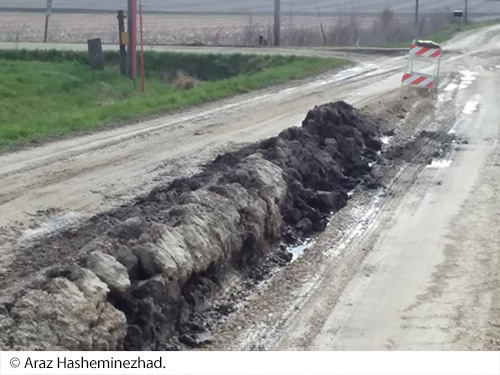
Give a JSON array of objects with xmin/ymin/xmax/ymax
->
[{"xmin": 202, "ymin": 28, "xmax": 500, "ymax": 350}]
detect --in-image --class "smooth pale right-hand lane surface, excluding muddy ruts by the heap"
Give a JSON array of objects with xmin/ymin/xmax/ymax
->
[{"xmin": 304, "ymin": 30, "xmax": 500, "ymax": 350}]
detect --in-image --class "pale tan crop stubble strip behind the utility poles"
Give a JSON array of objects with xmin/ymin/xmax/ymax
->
[{"xmin": 0, "ymin": 12, "xmax": 372, "ymax": 45}]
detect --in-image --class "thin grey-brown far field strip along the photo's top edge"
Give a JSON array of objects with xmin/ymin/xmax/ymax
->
[{"xmin": 0, "ymin": 0, "xmax": 500, "ymax": 14}]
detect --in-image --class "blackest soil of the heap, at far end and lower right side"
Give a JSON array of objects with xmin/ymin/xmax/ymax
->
[{"xmin": 119, "ymin": 102, "xmax": 381, "ymax": 349}]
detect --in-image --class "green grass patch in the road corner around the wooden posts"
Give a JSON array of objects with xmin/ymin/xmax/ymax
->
[{"xmin": 0, "ymin": 52, "xmax": 347, "ymax": 149}]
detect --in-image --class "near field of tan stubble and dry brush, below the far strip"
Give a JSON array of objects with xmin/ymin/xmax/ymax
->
[{"xmin": 0, "ymin": 8, "xmax": 500, "ymax": 46}]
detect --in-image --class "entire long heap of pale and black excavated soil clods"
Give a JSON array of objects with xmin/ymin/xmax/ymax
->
[{"xmin": 0, "ymin": 102, "xmax": 382, "ymax": 350}]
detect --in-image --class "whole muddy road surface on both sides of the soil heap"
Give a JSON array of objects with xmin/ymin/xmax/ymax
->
[{"xmin": 0, "ymin": 27, "xmax": 500, "ymax": 350}]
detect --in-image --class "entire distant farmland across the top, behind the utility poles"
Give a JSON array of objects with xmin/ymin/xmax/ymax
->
[{"xmin": 0, "ymin": 0, "xmax": 500, "ymax": 46}]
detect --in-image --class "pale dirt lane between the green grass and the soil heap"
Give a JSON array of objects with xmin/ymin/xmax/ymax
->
[{"xmin": 0, "ymin": 51, "xmax": 402, "ymax": 274}]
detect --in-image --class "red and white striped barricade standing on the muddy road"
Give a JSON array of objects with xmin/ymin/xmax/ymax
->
[{"xmin": 402, "ymin": 40, "xmax": 443, "ymax": 90}]
